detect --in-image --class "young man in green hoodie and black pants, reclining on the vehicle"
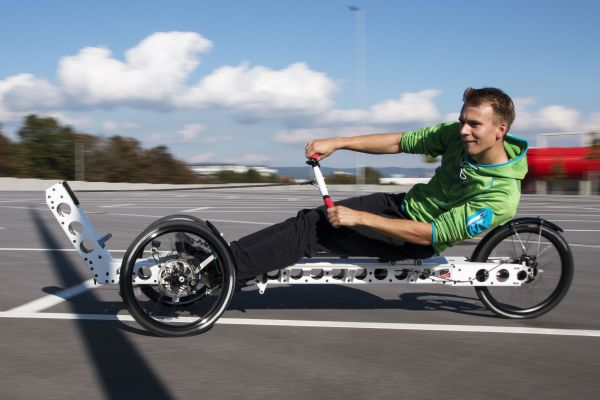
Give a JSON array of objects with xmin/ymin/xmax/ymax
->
[{"xmin": 231, "ymin": 88, "xmax": 527, "ymax": 281}]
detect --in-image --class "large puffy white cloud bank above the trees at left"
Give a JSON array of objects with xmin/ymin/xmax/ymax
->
[{"xmin": 0, "ymin": 32, "xmax": 337, "ymax": 119}]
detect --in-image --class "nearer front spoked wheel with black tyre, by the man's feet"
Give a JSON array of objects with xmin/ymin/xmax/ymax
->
[{"xmin": 120, "ymin": 219, "xmax": 235, "ymax": 336}]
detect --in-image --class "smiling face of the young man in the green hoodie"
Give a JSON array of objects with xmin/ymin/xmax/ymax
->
[{"xmin": 459, "ymin": 104, "xmax": 508, "ymax": 164}]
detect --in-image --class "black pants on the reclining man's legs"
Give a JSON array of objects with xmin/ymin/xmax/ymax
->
[{"xmin": 231, "ymin": 193, "xmax": 435, "ymax": 280}]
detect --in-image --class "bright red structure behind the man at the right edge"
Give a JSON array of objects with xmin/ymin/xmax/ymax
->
[{"xmin": 527, "ymin": 147, "xmax": 600, "ymax": 179}]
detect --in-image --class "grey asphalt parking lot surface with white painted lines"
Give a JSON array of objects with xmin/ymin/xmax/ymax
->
[{"xmin": 0, "ymin": 187, "xmax": 600, "ymax": 400}]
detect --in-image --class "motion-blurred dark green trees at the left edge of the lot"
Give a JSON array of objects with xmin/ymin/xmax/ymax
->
[{"xmin": 0, "ymin": 115, "xmax": 199, "ymax": 183}]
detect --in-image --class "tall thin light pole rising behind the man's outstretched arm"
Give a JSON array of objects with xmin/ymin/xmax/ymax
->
[{"xmin": 348, "ymin": 6, "xmax": 367, "ymax": 185}]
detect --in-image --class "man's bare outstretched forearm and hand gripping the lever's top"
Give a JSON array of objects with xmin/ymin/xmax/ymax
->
[{"xmin": 305, "ymin": 132, "xmax": 402, "ymax": 160}]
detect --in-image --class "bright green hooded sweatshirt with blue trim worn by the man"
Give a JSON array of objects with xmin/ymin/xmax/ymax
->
[{"xmin": 400, "ymin": 122, "xmax": 527, "ymax": 253}]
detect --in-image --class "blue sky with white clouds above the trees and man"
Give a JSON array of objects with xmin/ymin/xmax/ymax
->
[{"xmin": 0, "ymin": 0, "xmax": 600, "ymax": 167}]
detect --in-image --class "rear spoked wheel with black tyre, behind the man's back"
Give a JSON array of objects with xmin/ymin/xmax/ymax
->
[{"xmin": 472, "ymin": 220, "xmax": 573, "ymax": 318}]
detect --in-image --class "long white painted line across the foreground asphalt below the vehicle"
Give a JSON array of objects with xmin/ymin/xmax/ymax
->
[{"xmin": 0, "ymin": 311, "xmax": 600, "ymax": 337}]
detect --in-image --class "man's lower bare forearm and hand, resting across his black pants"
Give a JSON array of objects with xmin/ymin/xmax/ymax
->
[{"xmin": 327, "ymin": 206, "xmax": 432, "ymax": 245}]
